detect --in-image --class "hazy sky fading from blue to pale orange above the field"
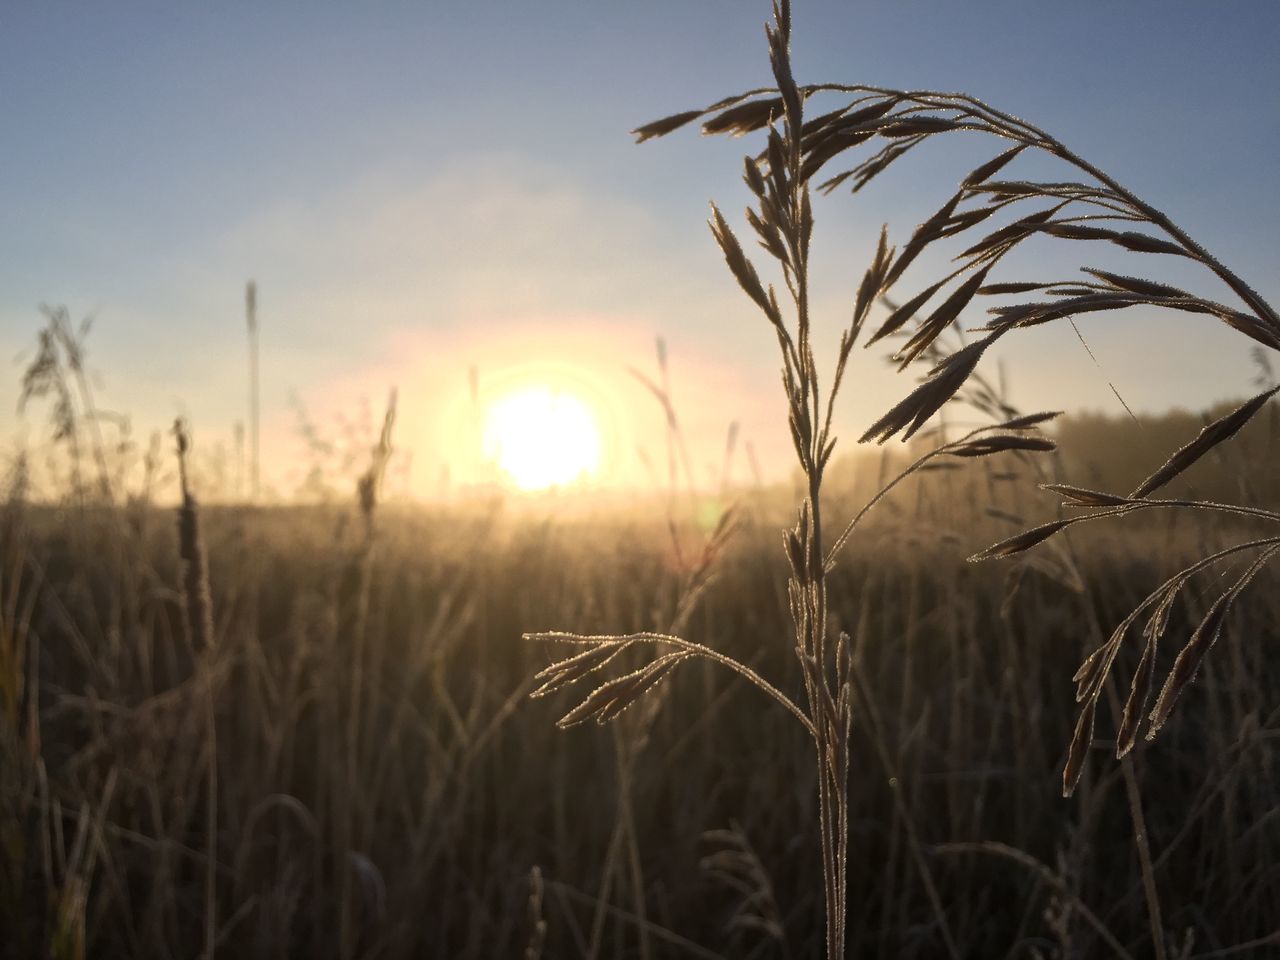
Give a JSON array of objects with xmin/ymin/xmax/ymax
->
[{"xmin": 0, "ymin": 0, "xmax": 1280, "ymax": 504}]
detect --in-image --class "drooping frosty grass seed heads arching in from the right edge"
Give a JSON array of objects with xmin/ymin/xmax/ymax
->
[{"xmin": 637, "ymin": 3, "xmax": 1280, "ymax": 795}]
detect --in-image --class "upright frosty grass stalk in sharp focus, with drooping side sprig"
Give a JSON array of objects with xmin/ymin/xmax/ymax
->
[{"xmin": 526, "ymin": 1, "xmax": 1053, "ymax": 960}]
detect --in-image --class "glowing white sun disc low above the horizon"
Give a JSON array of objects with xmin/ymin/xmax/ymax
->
[{"xmin": 484, "ymin": 387, "xmax": 602, "ymax": 490}]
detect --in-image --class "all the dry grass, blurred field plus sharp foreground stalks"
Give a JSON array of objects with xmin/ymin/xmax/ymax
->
[{"xmin": 0, "ymin": 3, "xmax": 1280, "ymax": 960}]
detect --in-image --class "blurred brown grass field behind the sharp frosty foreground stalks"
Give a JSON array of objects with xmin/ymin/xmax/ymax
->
[{"xmin": 0, "ymin": 442, "xmax": 1280, "ymax": 957}]
